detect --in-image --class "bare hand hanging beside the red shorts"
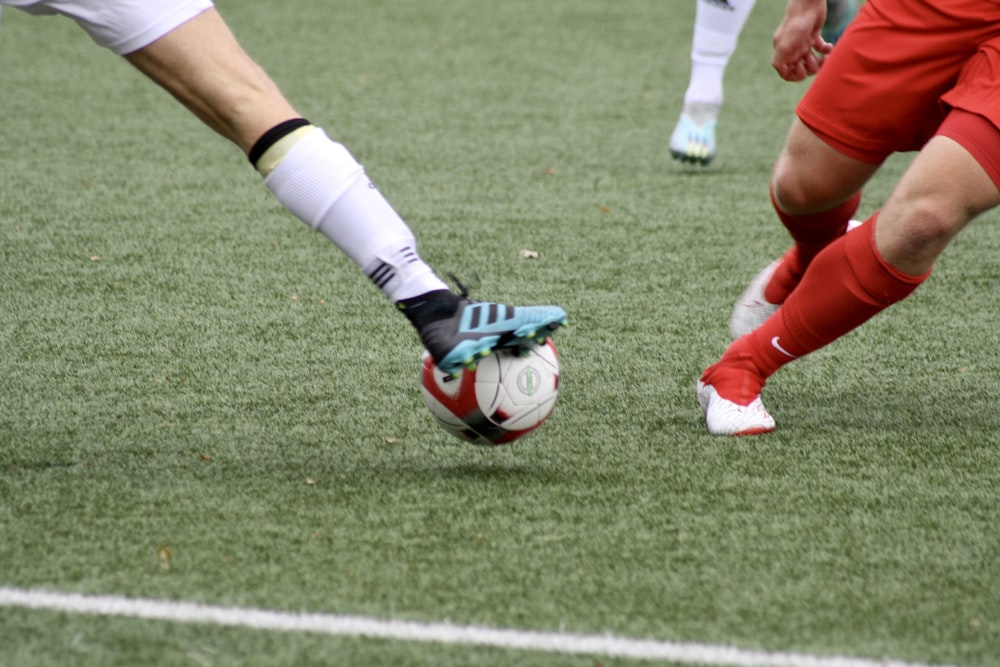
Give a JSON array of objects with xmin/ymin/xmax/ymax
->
[{"xmin": 771, "ymin": 0, "xmax": 833, "ymax": 81}]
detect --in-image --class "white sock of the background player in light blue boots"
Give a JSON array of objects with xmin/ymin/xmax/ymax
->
[{"xmin": 684, "ymin": 0, "xmax": 755, "ymax": 106}]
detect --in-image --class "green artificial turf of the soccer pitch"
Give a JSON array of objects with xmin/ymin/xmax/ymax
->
[{"xmin": 0, "ymin": 0, "xmax": 1000, "ymax": 667}]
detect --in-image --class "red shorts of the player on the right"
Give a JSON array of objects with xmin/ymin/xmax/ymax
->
[{"xmin": 796, "ymin": 0, "xmax": 1000, "ymax": 170}]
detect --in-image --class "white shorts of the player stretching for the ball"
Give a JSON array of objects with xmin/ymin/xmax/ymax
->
[{"xmin": 0, "ymin": 0, "xmax": 212, "ymax": 55}]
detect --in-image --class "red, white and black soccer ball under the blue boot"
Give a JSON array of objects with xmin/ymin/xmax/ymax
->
[{"xmin": 420, "ymin": 340, "xmax": 559, "ymax": 445}]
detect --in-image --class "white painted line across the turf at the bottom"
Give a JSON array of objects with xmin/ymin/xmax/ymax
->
[{"xmin": 0, "ymin": 587, "xmax": 960, "ymax": 667}]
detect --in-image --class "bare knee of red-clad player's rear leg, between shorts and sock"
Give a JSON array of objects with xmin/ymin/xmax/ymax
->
[{"xmin": 771, "ymin": 118, "xmax": 879, "ymax": 215}]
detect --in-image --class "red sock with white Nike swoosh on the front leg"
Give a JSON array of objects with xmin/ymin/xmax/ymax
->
[{"xmin": 702, "ymin": 214, "xmax": 930, "ymax": 405}]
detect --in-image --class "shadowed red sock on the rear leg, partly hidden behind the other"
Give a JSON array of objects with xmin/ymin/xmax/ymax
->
[{"xmin": 764, "ymin": 191, "xmax": 861, "ymax": 303}]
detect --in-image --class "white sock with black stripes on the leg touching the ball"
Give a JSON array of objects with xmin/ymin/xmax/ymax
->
[{"xmin": 264, "ymin": 128, "xmax": 447, "ymax": 302}]
